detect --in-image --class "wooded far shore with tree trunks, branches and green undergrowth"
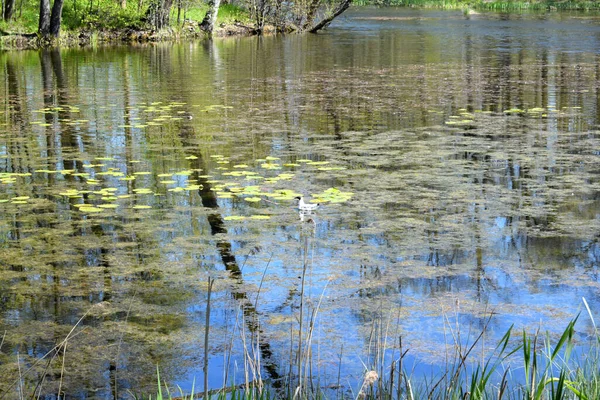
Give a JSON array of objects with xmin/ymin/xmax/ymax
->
[{"xmin": 0, "ymin": 0, "xmax": 599, "ymax": 49}]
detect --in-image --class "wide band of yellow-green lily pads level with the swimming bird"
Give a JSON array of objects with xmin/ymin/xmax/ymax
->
[{"xmin": 0, "ymin": 155, "xmax": 352, "ymax": 220}]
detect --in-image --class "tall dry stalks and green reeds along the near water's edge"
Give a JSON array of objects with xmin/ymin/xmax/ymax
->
[{"xmin": 8, "ymin": 270, "xmax": 600, "ymax": 400}]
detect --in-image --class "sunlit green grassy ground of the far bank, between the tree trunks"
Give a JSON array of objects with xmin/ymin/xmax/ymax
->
[{"xmin": 0, "ymin": 0, "xmax": 600, "ymax": 50}]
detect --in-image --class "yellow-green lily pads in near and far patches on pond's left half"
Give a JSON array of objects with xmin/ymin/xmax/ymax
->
[{"xmin": 0, "ymin": 102, "xmax": 352, "ymax": 220}]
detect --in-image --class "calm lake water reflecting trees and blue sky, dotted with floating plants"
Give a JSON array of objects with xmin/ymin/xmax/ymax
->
[{"xmin": 0, "ymin": 8, "xmax": 600, "ymax": 398}]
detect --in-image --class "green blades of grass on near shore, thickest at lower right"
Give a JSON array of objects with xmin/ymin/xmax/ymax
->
[{"xmin": 144, "ymin": 299, "xmax": 600, "ymax": 400}]
